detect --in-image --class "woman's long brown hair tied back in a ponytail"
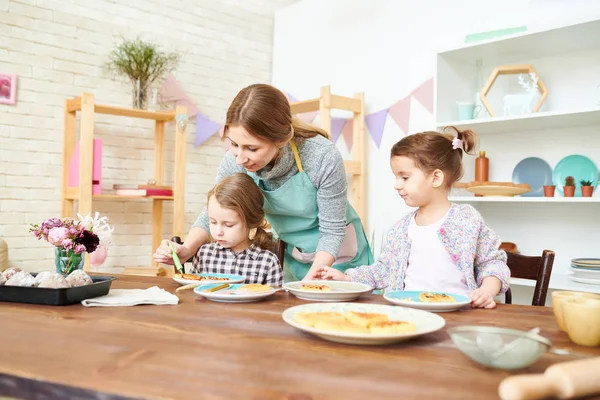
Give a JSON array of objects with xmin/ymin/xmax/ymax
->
[{"xmin": 223, "ymin": 83, "xmax": 329, "ymax": 143}]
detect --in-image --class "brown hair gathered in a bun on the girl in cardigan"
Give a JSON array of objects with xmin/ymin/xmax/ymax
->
[{"xmin": 391, "ymin": 126, "xmax": 477, "ymax": 188}]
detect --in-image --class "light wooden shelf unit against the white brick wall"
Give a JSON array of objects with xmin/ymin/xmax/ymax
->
[{"xmin": 61, "ymin": 93, "xmax": 187, "ymax": 270}]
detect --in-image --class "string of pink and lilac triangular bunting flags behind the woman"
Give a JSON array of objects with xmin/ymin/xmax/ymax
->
[{"xmin": 159, "ymin": 74, "xmax": 434, "ymax": 150}]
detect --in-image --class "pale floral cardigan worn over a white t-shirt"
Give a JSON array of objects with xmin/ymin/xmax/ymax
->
[{"xmin": 346, "ymin": 204, "xmax": 510, "ymax": 293}]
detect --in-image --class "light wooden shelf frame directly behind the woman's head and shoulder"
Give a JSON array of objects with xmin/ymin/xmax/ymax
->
[{"xmin": 290, "ymin": 86, "xmax": 367, "ymax": 231}]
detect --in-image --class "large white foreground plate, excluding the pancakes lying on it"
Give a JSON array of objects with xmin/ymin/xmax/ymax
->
[{"xmin": 282, "ymin": 303, "xmax": 446, "ymax": 345}]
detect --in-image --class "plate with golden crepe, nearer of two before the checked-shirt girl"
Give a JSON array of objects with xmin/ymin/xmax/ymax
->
[{"xmin": 194, "ymin": 283, "xmax": 277, "ymax": 303}]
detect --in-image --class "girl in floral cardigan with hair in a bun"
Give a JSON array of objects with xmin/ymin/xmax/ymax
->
[{"xmin": 304, "ymin": 127, "xmax": 510, "ymax": 308}]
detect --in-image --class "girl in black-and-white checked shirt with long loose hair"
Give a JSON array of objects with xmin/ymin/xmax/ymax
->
[{"xmin": 192, "ymin": 173, "xmax": 283, "ymax": 286}]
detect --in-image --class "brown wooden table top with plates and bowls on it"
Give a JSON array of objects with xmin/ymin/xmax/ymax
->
[{"xmin": 0, "ymin": 276, "xmax": 600, "ymax": 400}]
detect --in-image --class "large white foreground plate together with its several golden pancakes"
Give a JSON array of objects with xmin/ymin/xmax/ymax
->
[{"xmin": 282, "ymin": 303, "xmax": 446, "ymax": 345}]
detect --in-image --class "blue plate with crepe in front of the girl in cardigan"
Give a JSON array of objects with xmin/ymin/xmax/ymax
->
[{"xmin": 383, "ymin": 290, "xmax": 471, "ymax": 312}]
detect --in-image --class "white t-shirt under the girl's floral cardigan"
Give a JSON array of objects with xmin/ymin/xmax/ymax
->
[{"xmin": 404, "ymin": 213, "xmax": 469, "ymax": 295}]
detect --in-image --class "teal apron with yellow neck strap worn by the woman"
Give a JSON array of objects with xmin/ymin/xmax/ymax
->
[{"xmin": 251, "ymin": 140, "xmax": 373, "ymax": 282}]
